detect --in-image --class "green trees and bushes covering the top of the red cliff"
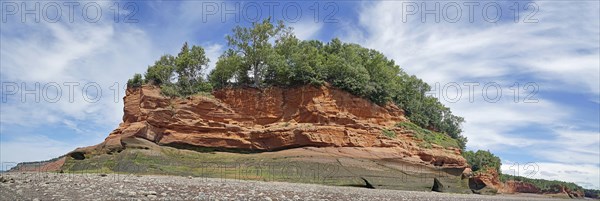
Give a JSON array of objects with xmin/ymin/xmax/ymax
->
[{"xmin": 128, "ymin": 19, "xmax": 466, "ymax": 148}]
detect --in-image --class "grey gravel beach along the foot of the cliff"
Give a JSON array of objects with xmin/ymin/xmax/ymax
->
[{"xmin": 0, "ymin": 172, "xmax": 561, "ymax": 201}]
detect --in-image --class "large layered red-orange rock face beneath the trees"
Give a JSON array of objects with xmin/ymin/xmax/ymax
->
[{"xmin": 76, "ymin": 85, "xmax": 467, "ymax": 168}]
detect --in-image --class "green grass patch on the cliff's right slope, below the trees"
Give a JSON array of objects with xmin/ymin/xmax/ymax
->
[{"xmin": 396, "ymin": 122, "xmax": 460, "ymax": 148}]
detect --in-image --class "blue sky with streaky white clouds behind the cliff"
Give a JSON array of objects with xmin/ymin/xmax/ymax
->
[{"xmin": 0, "ymin": 1, "xmax": 600, "ymax": 188}]
